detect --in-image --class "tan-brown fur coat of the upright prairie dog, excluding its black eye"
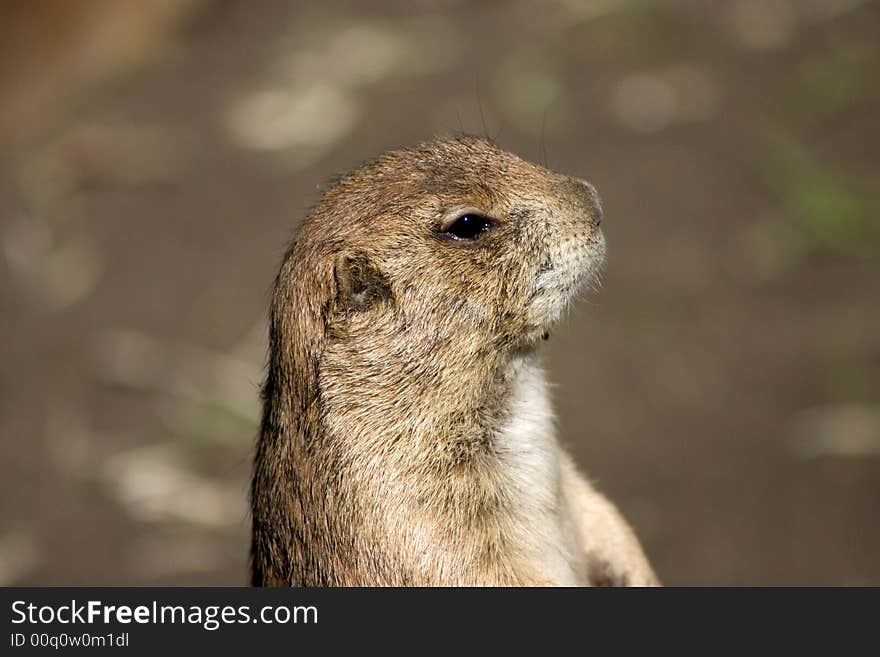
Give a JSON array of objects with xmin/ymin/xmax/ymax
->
[{"xmin": 251, "ymin": 137, "xmax": 655, "ymax": 586}]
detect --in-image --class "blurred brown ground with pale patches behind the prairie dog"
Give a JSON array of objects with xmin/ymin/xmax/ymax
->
[{"xmin": 0, "ymin": 0, "xmax": 880, "ymax": 585}]
